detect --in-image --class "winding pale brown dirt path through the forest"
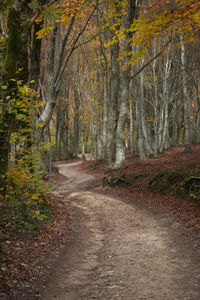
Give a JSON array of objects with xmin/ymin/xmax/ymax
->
[{"xmin": 40, "ymin": 162, "xmax": 200, "ymax": 300}]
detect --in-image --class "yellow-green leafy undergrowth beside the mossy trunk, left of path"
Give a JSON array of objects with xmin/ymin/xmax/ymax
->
[{"xmin": 0, "ymin": 82, "xmax": 52, "ymax": 255}]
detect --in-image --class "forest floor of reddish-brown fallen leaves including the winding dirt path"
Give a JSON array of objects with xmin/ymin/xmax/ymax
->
[{"xmin": 0, "ymin": 146, "xmax": 200, "ymax": 300}]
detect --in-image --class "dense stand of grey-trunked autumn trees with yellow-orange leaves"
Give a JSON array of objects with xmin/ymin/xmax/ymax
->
[{"xmin": 0, "ymin": 0, "xmax": 200, "ymax": 190}]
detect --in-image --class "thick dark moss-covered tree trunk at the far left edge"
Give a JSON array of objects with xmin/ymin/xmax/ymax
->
[{"xmin": 0, "ymin": 4, "xmax": 30, "ymax": 195}]
